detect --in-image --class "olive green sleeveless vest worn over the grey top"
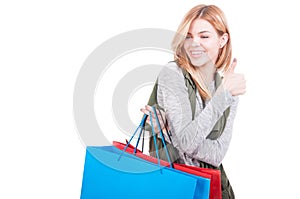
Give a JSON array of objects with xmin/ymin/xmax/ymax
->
[{"xmin": 146, "ymin": 64, "xmax": 234, "ymax": 199}]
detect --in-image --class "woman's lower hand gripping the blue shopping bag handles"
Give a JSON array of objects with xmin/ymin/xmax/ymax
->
[{"xmin": 140, "ymin": 105, "xmax": 169, "ymax": 133}]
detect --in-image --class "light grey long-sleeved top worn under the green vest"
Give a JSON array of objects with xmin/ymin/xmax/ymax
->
[{"xmin": 157, "ymin": 62, "xmax": 238, "ymax": 166}]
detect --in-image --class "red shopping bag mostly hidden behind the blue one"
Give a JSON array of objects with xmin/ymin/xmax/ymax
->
[{"xmin": 113, "ymin": 141, "xmax": 222, "ymax": 199}]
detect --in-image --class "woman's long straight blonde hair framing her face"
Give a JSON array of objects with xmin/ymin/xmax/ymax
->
[{"xmin": 172, "ymin": 4, "xmax": 232, "ymax": 100}]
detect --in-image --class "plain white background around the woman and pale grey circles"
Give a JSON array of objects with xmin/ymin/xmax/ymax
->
[{"xmin": 0, "ymin": 0, "xmax": 300, "ymax": 199}]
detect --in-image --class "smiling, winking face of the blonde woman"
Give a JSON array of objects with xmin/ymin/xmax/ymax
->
[{"xmin": 184, "ymin": 19, "xmax": 228, "ymax": 67}]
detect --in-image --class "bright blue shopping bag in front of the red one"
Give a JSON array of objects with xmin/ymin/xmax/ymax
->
[{"xmin": 81, "ymin": 146, "xmax": 210, "ymax": 199}]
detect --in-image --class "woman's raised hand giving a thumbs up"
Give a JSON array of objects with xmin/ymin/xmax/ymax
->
[{"xmin": 222, "ymin": 58, "xmax": 246, "ymax": 96}]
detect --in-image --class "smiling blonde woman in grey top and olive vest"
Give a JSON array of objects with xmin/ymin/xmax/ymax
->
[{"xmin": 142, "ymin": 5, "xmax": 246, "ymax": 199}]
